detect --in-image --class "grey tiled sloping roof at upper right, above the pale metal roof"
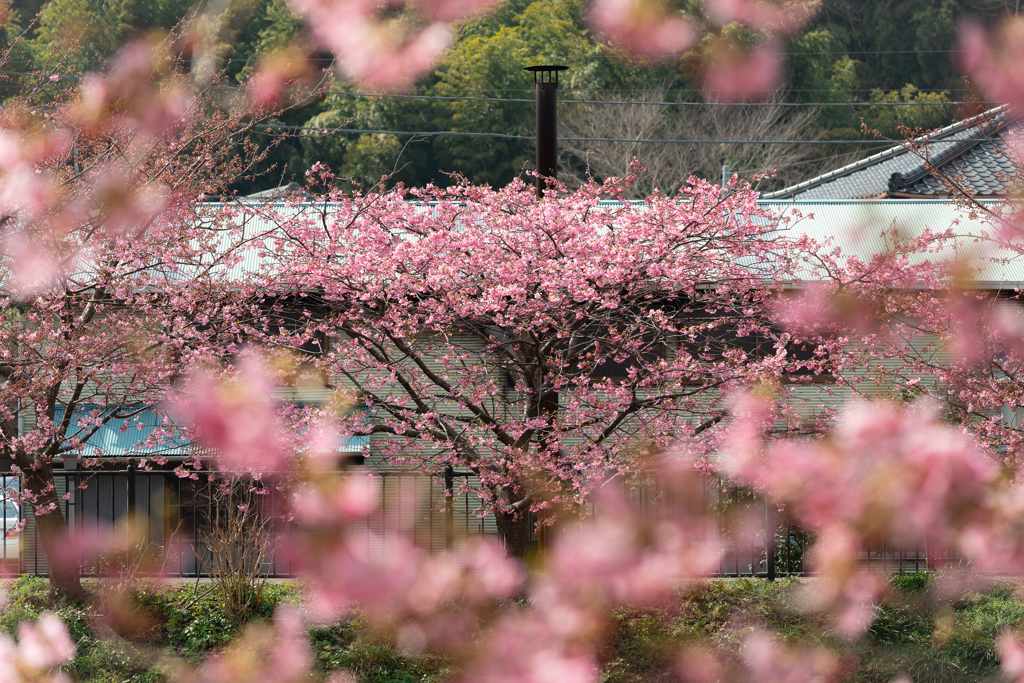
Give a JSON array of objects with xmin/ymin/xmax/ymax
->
[{"xmin": 762, "ymin": 108, "xmax": 1024, "ymax": 201}]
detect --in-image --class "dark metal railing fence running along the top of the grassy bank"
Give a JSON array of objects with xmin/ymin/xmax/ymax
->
[{"xmin": 9, "ymin": 468, "xmax": 959, "ymax": 579}]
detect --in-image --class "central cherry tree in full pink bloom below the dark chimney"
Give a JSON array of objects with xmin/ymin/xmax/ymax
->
[{"xmin": 226, "ymin": 169, "xmax": 821, "ymax": 555}]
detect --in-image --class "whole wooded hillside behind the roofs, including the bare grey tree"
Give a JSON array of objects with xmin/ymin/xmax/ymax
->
[{"xmin": 3, "ymin": 0, "xmax": 1007, "ymax": 195}]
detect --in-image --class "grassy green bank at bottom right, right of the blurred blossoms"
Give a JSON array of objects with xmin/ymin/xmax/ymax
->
[{"xmin": 602, "ymin": 574, "xmax": 1024, "ymax": 683}]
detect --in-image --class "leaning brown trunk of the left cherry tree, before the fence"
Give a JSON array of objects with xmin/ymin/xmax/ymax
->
[{"xmin": 23, "ymin": 463, "xmax": 85, "ymax": 599}]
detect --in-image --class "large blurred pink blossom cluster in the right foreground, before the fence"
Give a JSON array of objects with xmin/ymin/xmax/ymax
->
[{"xmin": 724, "ymin": 398, "xmax": 999, "ymax": 635}]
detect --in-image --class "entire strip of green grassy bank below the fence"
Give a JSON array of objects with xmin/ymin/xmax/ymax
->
[{"xmin": 0, "ymin": 574, "xmax": 1024, "ymax": 683}]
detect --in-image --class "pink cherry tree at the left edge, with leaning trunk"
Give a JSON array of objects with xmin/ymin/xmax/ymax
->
[{"xmin": 0, "ymin": 36, "xmax": 311, "ymax": 595}]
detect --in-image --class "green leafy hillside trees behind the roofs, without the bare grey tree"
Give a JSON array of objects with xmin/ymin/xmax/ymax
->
[{"xmin": 12, "ymin": 0, "xmax": 1015, "ymax": 194}]
